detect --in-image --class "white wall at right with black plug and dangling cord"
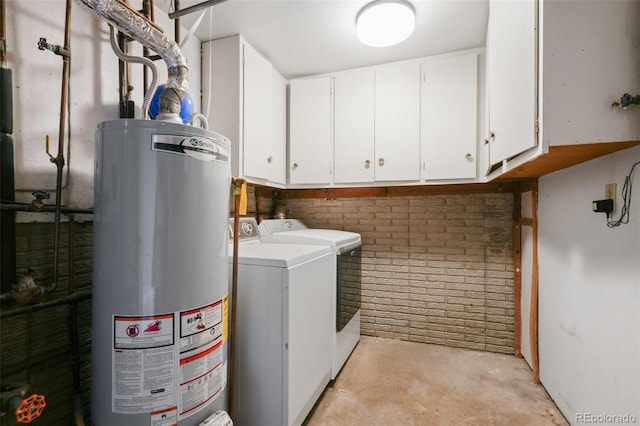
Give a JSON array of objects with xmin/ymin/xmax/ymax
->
[{"xmin": 538, "ymin": 147, "xmax": 640, "ymax": 423}]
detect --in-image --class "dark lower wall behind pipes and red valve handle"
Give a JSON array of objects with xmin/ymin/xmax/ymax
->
[{"xmin": 0, "ymin": 221, "xmax": 93, "ymax": 425}]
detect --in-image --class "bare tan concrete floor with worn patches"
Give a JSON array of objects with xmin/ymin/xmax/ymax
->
[{"xmin": 306, "ymin": 336, "xmax": 568, "ymax": 426}]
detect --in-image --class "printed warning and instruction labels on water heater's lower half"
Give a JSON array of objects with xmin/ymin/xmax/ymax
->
[{"xmin": 111, "ymin": 295, "xmax": 228, "ymax": 420}]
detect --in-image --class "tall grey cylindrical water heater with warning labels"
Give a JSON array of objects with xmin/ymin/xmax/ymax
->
[{"xmin": 91, "ymin": 120, "xmax": 231, "ymax": 426}]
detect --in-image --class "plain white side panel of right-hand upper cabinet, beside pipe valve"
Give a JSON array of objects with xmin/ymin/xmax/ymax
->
[{"xmin": 540, "ymin": 0, "xmax": 640, "ymax": 146}]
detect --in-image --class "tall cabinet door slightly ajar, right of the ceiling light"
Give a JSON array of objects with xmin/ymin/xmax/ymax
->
[{"xmin": 487, "ymin": 0, "xmax": 537, "ymax": 164}]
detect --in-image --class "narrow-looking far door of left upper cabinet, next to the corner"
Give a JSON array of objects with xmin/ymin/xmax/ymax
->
[{"xmin": 267, "ymin": 69, "xmax": 287, "ymax": 184}]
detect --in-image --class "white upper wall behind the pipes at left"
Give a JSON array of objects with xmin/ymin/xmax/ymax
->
[{"xmin": 6, "ymin": 0, "xmax": 200, "ymax": 216}]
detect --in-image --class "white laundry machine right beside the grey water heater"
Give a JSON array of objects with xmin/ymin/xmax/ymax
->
[{"xmin": 230, "ymin": 218, "xmax": 334, "ymax": 426}]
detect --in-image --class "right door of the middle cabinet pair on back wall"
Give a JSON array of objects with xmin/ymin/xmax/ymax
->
[{"xmin": 374, "ymin": 63, "xmax": 420, "ymax": 181}]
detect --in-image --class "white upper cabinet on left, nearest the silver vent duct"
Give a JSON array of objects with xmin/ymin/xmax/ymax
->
[{"xmin": 202, "ymin": 36, "xmax": 286, "ymax": 185}]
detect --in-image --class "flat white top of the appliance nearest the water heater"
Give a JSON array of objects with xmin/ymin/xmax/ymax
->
[{"xmin": 232, "ymin": 243, "xmax": 331, "ymax": 268}]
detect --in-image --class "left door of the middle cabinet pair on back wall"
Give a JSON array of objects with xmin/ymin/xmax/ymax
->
[{"xmin": 333, "ymin": 69, "xmax": 375, "ymax": 183}]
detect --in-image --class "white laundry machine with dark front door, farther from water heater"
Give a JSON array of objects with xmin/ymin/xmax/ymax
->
[{"xmin": 260, "ymin": 219, "xmax": 362, "ymax": 380}]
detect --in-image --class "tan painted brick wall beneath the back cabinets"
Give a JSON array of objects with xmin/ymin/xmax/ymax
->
[{"xmin": 286, "ymin": 193, "xmax": 514, "ymax": 353}]
